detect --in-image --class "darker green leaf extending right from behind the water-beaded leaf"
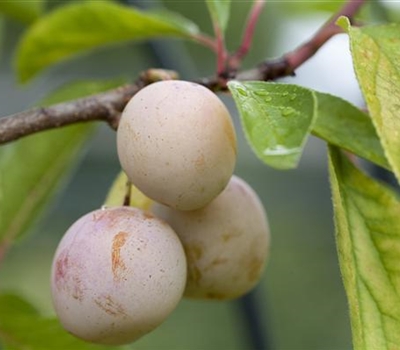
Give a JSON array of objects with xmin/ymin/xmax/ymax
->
[{"xmin": 312, "ymin": 92, "xmax": 390, "ymax": 169}]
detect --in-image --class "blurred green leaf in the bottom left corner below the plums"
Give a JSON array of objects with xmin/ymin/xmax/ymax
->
[{"xmin": 0, "ymin": 294, "xmax": 122, "ymax": 350}]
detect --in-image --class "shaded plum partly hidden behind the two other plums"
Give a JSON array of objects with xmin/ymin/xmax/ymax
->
[{"xmin": 152, "ymin": 176, "xmax": 270, "ymax": 300}]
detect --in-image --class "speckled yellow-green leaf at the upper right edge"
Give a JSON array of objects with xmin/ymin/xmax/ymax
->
[{"xmin": 339, "ymin": 17, "xmax": 400, "ymax": 182}]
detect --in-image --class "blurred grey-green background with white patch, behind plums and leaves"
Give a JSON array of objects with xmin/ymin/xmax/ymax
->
[{"xmin": 0, "ymin": 0, "xmax": 393, "ymax": 350}]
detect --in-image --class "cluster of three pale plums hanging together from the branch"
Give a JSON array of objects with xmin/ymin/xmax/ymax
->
[{"xmin": 52, "ymin": 80, "xmax": 269, "ymax": 344}]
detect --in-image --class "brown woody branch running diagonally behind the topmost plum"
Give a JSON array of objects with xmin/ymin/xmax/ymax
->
[{"xmin": 0, "ymin": 0, "xmax": 365, "ymax": 144}]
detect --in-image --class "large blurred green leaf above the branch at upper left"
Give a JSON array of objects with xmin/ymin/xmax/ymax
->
[{"xmin": 16, "ymin": 1, "xmax": 197, "ymax": 82}]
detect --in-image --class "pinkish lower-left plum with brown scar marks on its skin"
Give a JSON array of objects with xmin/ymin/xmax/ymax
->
[{"xmin": 51, "ymin": 207, "xmax": 186, "ymax": 345}]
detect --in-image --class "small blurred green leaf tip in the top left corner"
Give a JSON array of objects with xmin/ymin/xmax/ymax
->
[{"xmin": 0, "ymin": 0, "xmax": 44, "ymax": 24}]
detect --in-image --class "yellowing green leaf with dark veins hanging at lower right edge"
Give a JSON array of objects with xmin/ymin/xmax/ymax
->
[{"xmin": 330, "ymin": 147, "xmax": 400, "ymax": 350}]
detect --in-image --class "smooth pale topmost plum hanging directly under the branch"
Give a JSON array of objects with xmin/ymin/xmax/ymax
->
[{"xmin": 117, "ymin": 80, "xmax": 236, "ymax": 210}]
